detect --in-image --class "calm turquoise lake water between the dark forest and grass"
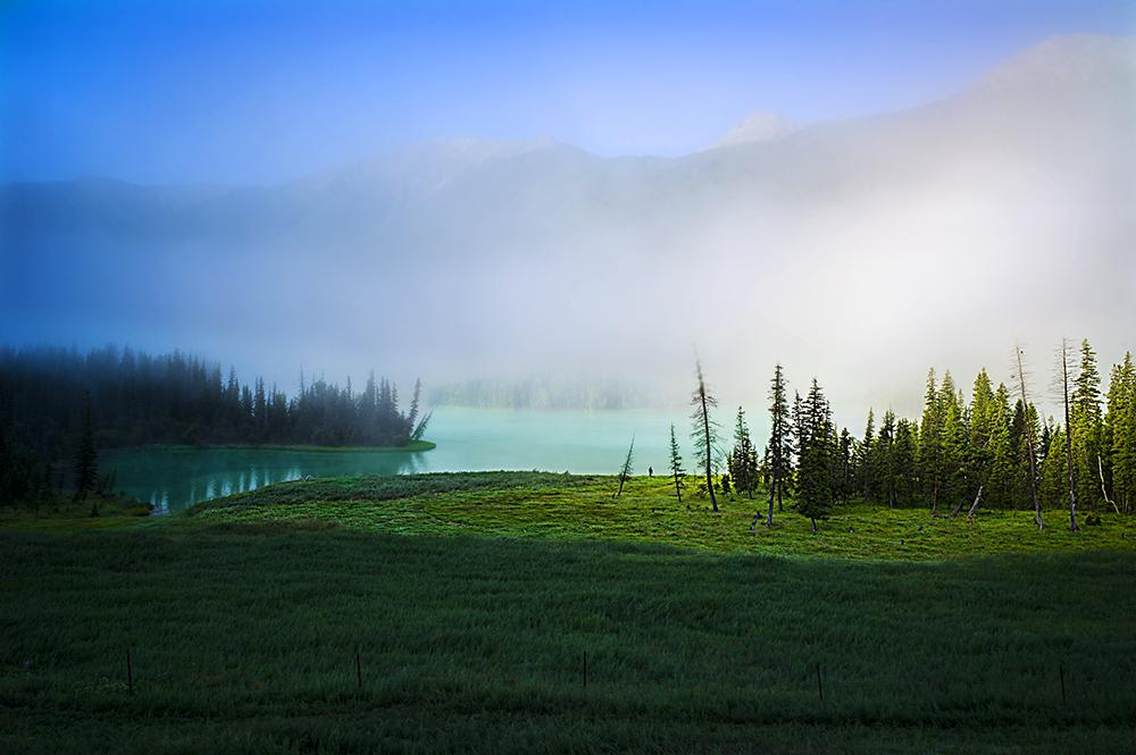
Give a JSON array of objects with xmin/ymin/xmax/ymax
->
[{"xmin": 100, "ymin": 406, "xmax": 691, "ymax": 513}]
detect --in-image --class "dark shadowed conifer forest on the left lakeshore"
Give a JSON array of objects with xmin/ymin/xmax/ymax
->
[{"xmin": 0, "ymin": 346, "xmax": 428, "ymax": 502}]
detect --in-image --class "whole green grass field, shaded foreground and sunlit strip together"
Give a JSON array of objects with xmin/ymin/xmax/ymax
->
[{"xmin": 0, "ymin": 473, "xmax": 1136, "ymax": 753}]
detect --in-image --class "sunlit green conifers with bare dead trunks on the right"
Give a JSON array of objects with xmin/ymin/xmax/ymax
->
[{"xmin": 670, "ymin": 339, "xmax": 1136, "ymax": 530}]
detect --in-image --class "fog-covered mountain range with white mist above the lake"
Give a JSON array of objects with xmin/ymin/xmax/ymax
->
[{"xmin": 0, "ymin": 16, "xmax": 1136, "ymax": 426}]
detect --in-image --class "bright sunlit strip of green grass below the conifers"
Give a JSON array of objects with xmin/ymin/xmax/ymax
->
[{"xmin": 189, "ymin": 472, "xmax": 1136, "ymax": 560}]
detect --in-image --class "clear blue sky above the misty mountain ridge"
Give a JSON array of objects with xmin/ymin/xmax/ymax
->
[{"xmin": 0, "ymin": 0, "xmax": 1136, "ymax": 183}]
